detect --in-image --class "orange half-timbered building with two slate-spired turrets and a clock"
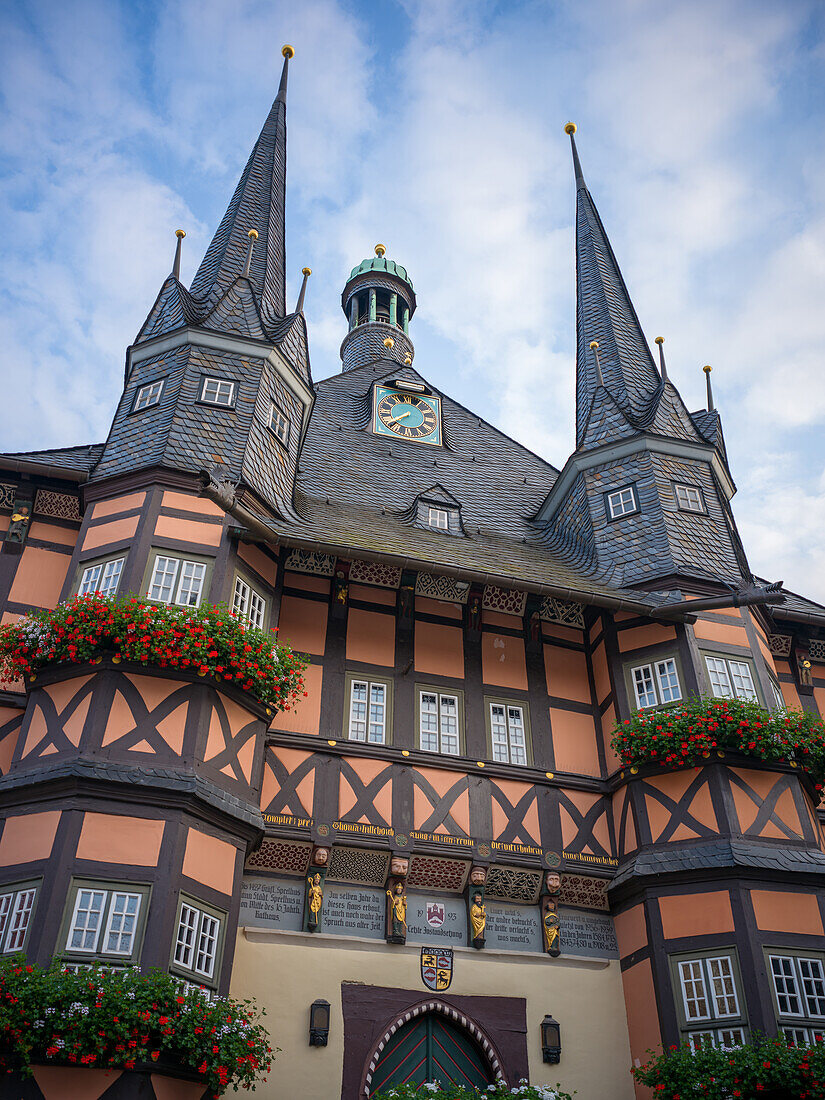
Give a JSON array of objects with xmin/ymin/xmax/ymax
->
[{"xmin": 0, "ymin": 47, "xmax": 825, "ymax": 1100}]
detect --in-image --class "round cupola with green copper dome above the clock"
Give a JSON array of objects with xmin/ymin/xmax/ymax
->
[{"xmin": 341, "ymin": 244, "xmax": 416, "ymax": 371}]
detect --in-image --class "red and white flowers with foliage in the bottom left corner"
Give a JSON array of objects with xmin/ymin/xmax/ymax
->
[{"xmin": 0, "ymin": 956, "xmax": 273, "ymax": 1097}]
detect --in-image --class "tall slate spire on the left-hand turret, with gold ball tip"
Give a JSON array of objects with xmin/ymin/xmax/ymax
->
[{"xmin": 191, "ymin": 46, "xmax": 295, "ymax": 323}]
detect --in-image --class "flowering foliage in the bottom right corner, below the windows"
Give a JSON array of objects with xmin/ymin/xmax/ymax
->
[{"xmin": 631, "ymin": 1037, "xmax": 825, "ymax": 1100}]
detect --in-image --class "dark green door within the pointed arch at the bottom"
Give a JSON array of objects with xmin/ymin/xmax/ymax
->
[{"xmin": 365, "ymin": 1005, "xmax": 498, "ymax": 1096}]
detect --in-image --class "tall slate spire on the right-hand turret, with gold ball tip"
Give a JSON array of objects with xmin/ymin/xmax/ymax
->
[{"xmin": 564, "ymin": 122, "xmax": 661, "ymax": 447}]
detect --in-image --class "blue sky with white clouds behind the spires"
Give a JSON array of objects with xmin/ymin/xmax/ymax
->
[{"xmin": 0, "ymin": 0, "xmax": 825, "ymax": 600}]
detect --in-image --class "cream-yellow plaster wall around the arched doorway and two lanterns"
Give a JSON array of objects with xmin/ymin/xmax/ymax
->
[{"xmin": 231, "ymin": 928, "xmax": 634, "ymax": 1100}]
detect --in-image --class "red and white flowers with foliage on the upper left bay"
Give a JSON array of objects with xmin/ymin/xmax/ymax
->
[{"xmin": 0, "ymin": 594, "xmax": 308, "ymax": 711}]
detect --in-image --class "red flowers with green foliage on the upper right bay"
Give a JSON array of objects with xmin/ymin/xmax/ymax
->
[{"xmin": 611, "ymin": 699, "xmax": 825, "ymax": 790}]
